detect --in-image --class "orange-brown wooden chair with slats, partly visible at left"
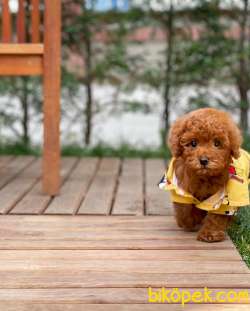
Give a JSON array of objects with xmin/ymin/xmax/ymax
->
[{"xmin": 0, "ymin": 0, "xmax": 61, "ymax": 195}]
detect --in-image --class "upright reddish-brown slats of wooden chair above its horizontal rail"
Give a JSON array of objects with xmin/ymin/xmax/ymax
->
[{"xmin": 1, "ymin": 0, "xmax": 41, "ymax": 43}]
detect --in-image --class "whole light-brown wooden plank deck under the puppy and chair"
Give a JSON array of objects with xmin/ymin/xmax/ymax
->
[{"xmin": 0, "ymin": 157, "xmax": 250, "ymax": 311}]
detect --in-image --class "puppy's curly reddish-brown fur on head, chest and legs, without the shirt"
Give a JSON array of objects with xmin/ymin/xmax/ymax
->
[{"xmin": 168, "ymin": 108, "xmax": 242, "ymax": 242}]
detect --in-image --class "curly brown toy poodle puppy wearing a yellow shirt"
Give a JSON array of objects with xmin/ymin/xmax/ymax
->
[{"xmin": 159, "ymin": 108, "xmax": 250, "ymax": 242}]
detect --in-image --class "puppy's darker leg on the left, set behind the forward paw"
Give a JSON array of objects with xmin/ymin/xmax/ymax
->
[{"xmin": 173, "ymin": 203, "xmax": 207, "ymax": 231}]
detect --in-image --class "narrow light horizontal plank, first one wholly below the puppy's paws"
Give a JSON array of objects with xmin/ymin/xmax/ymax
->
[{"xmin": 0, "ymin": 249, "xmax": 242, "ymax": 262}]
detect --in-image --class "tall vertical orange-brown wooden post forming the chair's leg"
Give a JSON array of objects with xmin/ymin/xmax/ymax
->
[{"xmin": 43, "ymin": 0, "xmax": 61, "ymax": 195}]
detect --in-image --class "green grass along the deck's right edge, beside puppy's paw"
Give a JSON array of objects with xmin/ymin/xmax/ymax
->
[{"xmin": 228, "ymin": 207, "xmax": 250, "ymax": 268}]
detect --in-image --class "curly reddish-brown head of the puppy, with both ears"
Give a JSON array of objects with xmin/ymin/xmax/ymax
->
[{"xmin": 168, "ymin": 108, "xmax": 242, "ymax": 176}]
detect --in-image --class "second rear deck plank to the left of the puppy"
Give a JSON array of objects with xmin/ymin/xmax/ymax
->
[{"xmin": 112, "ymin": 159, "xmax": 144, "ymax": 215}]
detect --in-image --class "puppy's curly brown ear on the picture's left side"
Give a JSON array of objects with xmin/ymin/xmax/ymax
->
[{"xmin": 167, "ymin": 116, "xmax": 186, "ymax": 157}]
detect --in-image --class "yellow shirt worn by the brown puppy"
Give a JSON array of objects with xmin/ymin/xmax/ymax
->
[{"xmin": 159, "ymin": 149, "xmax": 250, "ymax": 215}]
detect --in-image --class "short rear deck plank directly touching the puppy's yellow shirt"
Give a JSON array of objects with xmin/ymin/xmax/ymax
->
[{"xmin": 145, "ymin": 159, "xmax": 173, "ymax": 215}]
